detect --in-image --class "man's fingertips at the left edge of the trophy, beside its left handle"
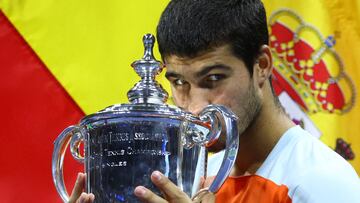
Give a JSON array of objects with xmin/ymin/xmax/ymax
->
[{"xmin": 68, "ymin": 173, "xmax": 95, "ymax": 203}]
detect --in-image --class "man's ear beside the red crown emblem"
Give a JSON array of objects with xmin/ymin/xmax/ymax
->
[{"xmin": 253, "ymin": 45, "xmax": 273, "ymax": 87}]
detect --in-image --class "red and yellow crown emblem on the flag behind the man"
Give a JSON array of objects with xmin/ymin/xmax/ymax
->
[{"xmin": 269, "ymin": 9, "xmax": 356, "ymax": 114}]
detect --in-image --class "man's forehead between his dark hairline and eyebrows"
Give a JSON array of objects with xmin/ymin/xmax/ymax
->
[{"xmin": 164, "ymin": 45, "xmax": 243, "ymax": 72}]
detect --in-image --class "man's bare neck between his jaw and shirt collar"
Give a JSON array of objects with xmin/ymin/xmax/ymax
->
[{"xmin": 231, "ymin": 90, "xmax": 295, "ymax": 176}]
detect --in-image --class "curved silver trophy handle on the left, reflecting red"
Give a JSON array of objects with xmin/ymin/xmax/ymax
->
[{"xmin": 52, "ymin": 126, "xmax": 84, "ymax": 202}]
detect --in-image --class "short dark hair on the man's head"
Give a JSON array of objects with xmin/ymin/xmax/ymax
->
[{"xmin": 157, "ymin": 0, "xmax": 268, "ymax": 75}]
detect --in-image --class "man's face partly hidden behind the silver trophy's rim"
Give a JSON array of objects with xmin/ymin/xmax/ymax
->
[{"xmin": 165, "ymin": 45, "xmax": 261, "ymax": 134}]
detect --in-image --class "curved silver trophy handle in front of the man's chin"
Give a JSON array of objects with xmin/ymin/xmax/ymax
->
[{"xmin": 192, "ymin": 105, "xmax": 239, "ymax": 202}]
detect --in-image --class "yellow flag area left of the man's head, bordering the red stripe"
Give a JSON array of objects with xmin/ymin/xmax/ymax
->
[{"xmin": 0, "ymin": 0, "xmax": 168, "ymax": 114}]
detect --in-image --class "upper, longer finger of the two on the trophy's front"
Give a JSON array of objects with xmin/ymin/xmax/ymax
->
[{"xmin": 151, "ymin": 171, "xmax": 191, "ymax": 202}]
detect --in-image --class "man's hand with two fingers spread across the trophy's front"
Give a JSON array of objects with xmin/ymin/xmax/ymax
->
[{"xmin": 134, "ymin": 171, "xmax": 192, "ymax": 203}]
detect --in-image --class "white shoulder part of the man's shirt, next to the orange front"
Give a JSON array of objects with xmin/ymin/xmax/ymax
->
[{"xmin": 258, "ymin": 126, "xmax": 360, "ymax": 203}]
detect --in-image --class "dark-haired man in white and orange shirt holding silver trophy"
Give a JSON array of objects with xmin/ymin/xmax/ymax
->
[{"xmin": 71, "ymin": 0, "xmax": 360, "ymax": 203}]
